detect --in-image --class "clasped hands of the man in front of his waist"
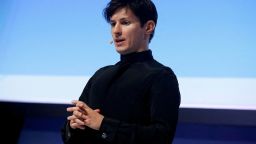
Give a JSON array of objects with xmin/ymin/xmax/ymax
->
[{"xmin": 67, "ymin": 100, "xmax": 104, "ymax": 130}]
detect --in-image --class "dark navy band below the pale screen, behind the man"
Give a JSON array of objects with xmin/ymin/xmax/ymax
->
[{"xmin": 0, "ymin": 102, "xmax": 256, "ymax": 144}]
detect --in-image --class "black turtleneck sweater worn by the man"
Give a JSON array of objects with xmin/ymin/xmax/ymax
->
[{"xmin": 62, "ymin": 50, "xmax": 180, "ymax": 144}]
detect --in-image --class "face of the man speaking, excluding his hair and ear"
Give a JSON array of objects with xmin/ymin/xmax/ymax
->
[{"xmin": 110, "ymin": 8, "xmax": 148, "ymax": 54}]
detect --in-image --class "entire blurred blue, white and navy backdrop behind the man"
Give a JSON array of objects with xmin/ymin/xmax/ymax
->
[{"xmin": 0, "ymin": 0, "xmax": 256, "ymax": 144}]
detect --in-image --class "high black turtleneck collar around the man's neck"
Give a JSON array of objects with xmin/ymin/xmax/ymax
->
[{"xmin": 120, "ymin": 49, "xmax": 153, "ymax": 63}]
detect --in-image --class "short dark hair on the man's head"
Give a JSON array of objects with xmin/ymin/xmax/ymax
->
[{"xmin": 103, "ymin": 0, "xmax": 158, "ymax": 42}]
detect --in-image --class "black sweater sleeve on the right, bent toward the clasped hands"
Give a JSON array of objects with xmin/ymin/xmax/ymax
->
[{"xmin": 100, "ymin": 69, "xmax": 180, "ymax": 144}]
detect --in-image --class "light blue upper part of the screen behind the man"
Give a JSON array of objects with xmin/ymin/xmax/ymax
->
[{"xmin": 0, "ymin": 0, "xmax": 256, "ymax": 77}]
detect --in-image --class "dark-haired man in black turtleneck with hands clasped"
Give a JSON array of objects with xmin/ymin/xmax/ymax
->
[{"xmin": 62, "ymin": 0, "xmax": 180, "ymax": 144}]
